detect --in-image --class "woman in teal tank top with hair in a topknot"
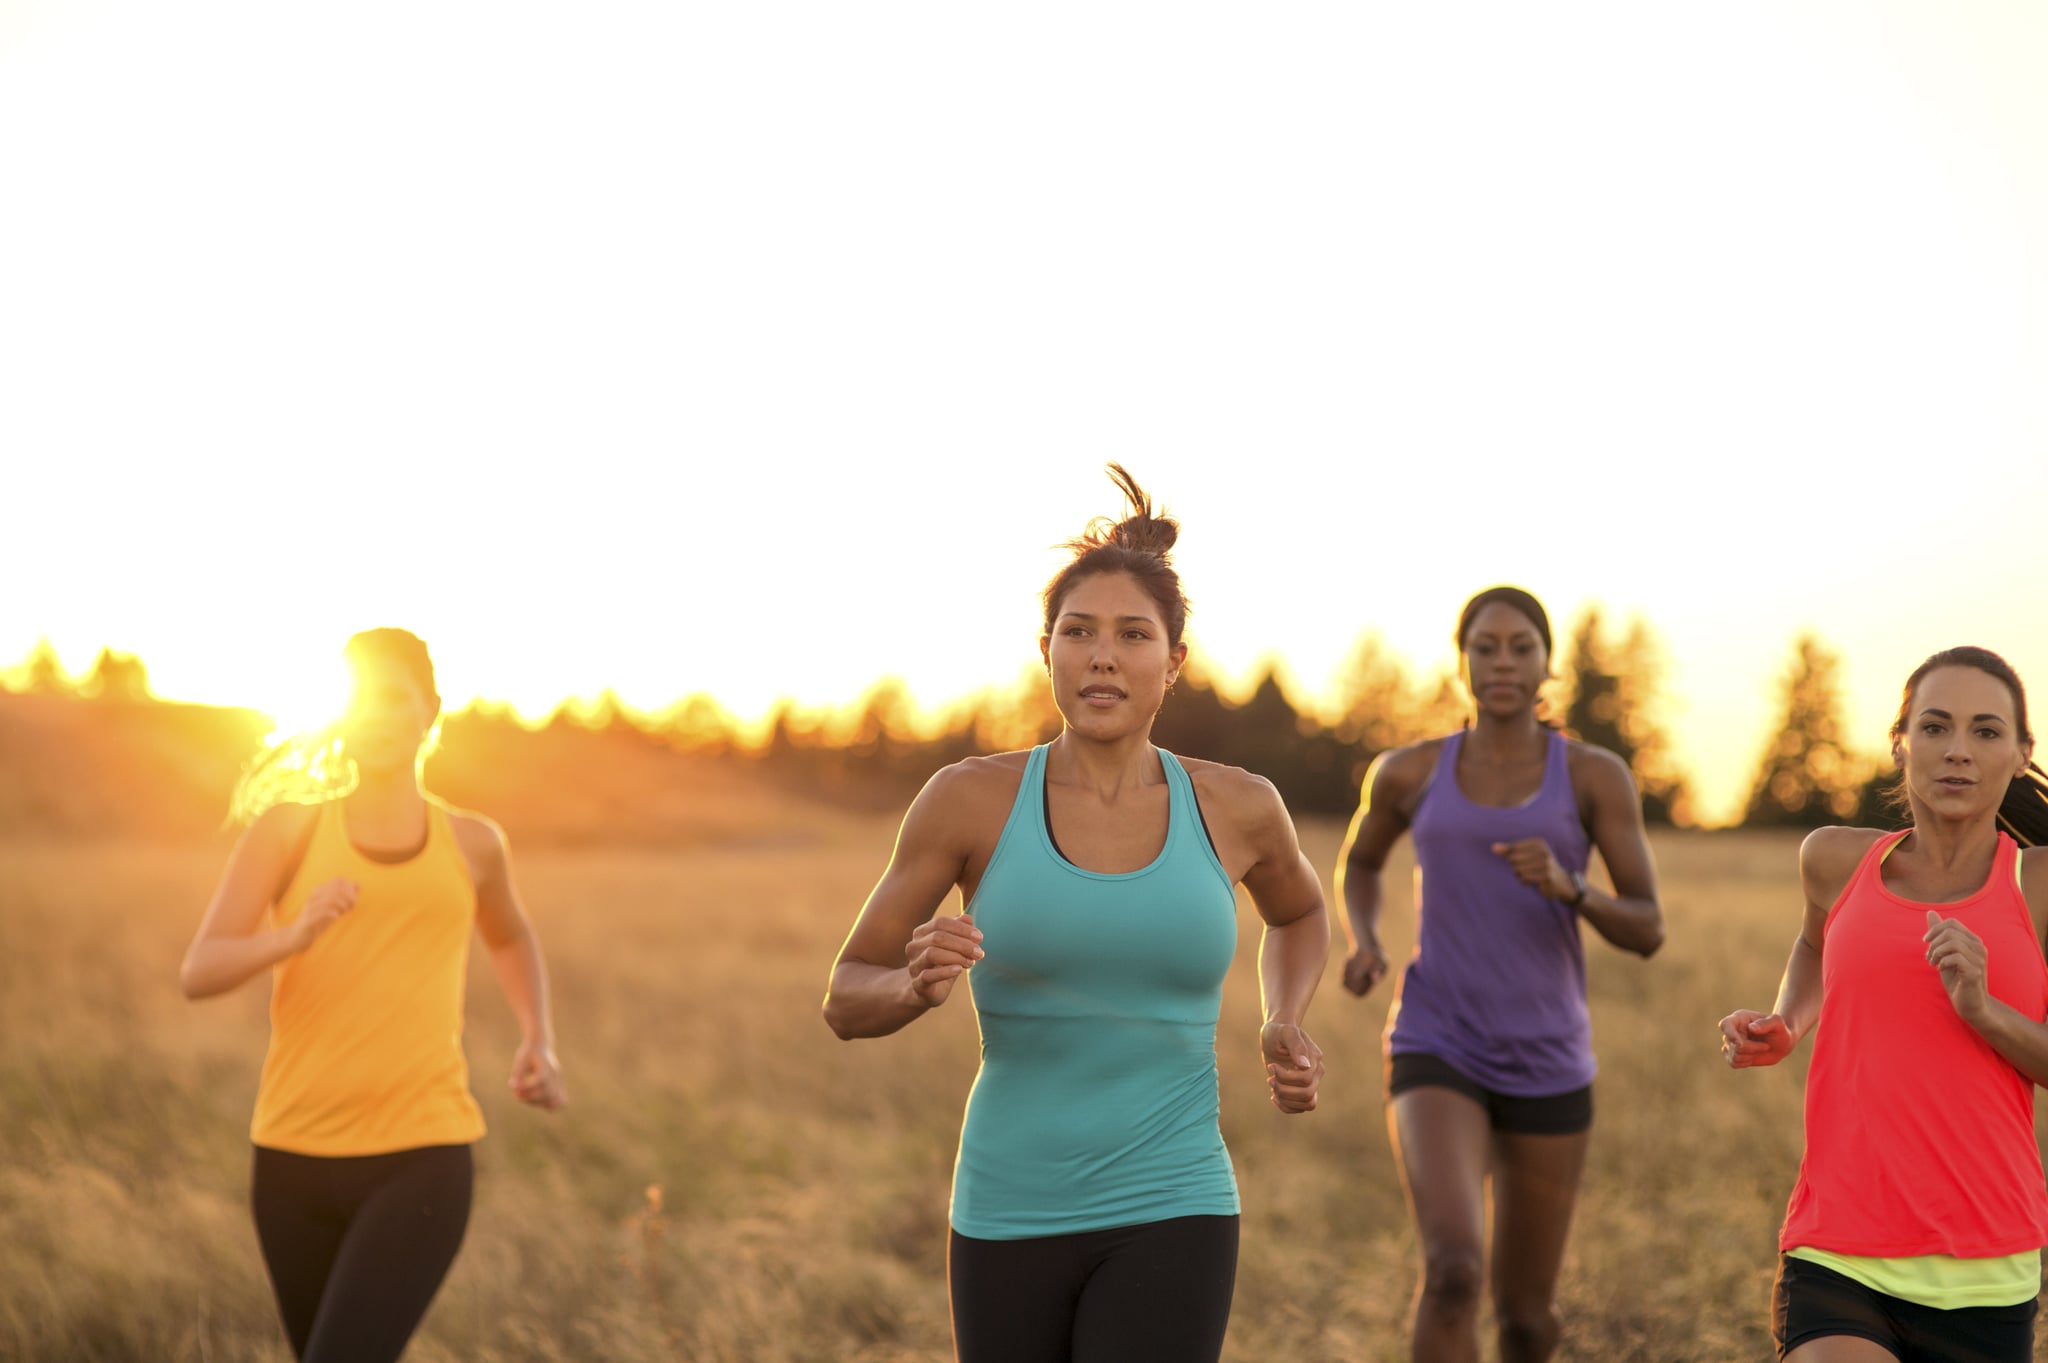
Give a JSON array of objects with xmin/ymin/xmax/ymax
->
[{"xmin": 825, "ymin": 465, "xmax": 1329, "ymax": 1363}]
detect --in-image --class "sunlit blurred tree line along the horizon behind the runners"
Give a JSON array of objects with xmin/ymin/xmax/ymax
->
[{"xmin": 0, "ymin": 622, "xmax": 1896, "ymax": 827}]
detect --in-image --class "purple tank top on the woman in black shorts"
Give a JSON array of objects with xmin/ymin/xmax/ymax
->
[{"xmin": 1384, "ymin": 733, "xmax": 1593, "ymax": 1097}]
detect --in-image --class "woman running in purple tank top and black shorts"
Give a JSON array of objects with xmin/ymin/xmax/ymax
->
[{"xmin": 1337, "ymin": 587, "xmax": 1663, "ymax": 1363}]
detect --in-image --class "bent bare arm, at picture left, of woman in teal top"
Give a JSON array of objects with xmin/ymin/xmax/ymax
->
[{"xmin": 825, "ymin": 765, "xmax": 981, "ymax": 1040}]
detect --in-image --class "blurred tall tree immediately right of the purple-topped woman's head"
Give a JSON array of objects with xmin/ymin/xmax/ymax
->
[{"xmin": 1565, "ymin": 606, "xmax": 1692, "ymax": 823}]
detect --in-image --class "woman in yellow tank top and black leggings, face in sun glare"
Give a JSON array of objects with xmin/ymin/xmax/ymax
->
[{"xmin": 180, "ymin": 630, "xmax": 563, "ymax": 1363}]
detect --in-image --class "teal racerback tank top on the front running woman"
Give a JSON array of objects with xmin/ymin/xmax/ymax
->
[{"xmin": 950, "ymin": 747, "xmax": 1237, "ymax": 1240}]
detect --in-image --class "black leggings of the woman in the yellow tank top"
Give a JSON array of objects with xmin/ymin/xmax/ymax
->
[{"xmin": 250, "ymin": 1146, "xmax": 473, "ymax": 1363}]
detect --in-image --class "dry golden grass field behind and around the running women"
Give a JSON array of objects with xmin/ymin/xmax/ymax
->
[{"xmin": 0, "ymin": 808, "xmax": 2048, "ymax": 1363}]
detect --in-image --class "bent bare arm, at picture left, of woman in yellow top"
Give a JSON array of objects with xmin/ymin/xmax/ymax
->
[{"xmin": 178, "ymin": 804, "xmax": 356, "ymax": 999}]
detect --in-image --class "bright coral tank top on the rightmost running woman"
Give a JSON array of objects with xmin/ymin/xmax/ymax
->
[{"xmin": 1778, "ymin": 833, "xmax": 2048, "ymax": 1259}]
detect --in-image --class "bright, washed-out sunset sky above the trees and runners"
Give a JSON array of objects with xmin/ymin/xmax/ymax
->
[{"xmin": 0, "ymin": 0, "xmax": 2048, "ymax": 817}]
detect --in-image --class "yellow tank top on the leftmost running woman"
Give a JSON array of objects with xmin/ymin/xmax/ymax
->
[{"xmin": 250, "ymin": 800, "xmax": 483, "ymax": 1156}]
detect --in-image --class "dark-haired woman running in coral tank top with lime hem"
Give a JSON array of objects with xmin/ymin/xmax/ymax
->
[{"xmin": 1720, "ymin": 649, "xmax": 2048, "ymax": 1363}]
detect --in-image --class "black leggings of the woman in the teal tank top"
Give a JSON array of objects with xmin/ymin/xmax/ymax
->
[{"xmin": 946, "ymin": 1216, "xmax": 1237, "ymax": 1363}]
